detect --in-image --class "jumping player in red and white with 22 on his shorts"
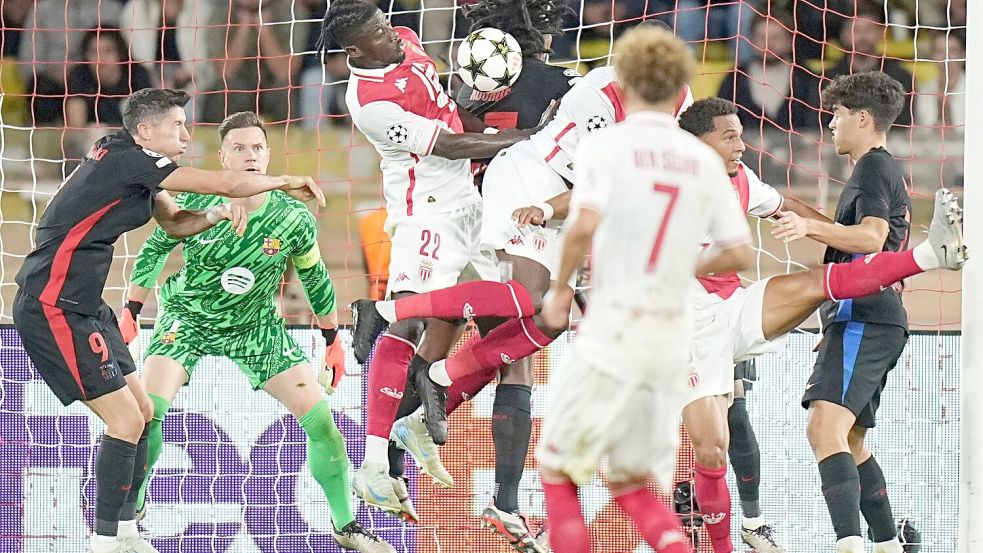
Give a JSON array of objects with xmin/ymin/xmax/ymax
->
[{"xmin": 322, "ymin": 0, "xmax": 552, "ymax": 513}]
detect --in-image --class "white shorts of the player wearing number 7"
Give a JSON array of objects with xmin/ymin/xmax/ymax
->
[{"xmin": 536, "ymin": 351, "xmax": 685, "ymax": 490}]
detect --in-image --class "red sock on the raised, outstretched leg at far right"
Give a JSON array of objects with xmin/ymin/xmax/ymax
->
[{"xmin": 823, "ymin": 250, "xmax": 925, "ymax": 300}]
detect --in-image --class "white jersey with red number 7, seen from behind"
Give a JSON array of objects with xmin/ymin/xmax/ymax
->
[{"xmin": 570, "ymin": 112, "xmax": 751, "ymax": 364}]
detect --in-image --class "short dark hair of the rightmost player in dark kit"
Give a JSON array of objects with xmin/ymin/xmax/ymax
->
[{"xmin": 823, "ymin": 71, "xmax": 905, "ymax": 132}]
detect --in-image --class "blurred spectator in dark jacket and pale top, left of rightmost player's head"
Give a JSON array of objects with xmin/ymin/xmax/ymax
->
[{"xmin": 717, "ymin": 13, "xmax": 819, "ymax": 129}]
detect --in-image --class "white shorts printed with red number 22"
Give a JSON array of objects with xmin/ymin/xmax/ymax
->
[{"xmin": 386, "ymin": 203, "xmax": 501, "ymax": 296}]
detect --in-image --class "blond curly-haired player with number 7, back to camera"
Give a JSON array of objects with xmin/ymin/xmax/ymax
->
[{"xmin": 536, "ymin": 27, "xmax": 751, "ymax": 553}]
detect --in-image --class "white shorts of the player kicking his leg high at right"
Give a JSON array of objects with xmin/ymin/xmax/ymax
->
[{"xmin": 686, "ymin": 277, "xmax": 785, "ymax": 405}]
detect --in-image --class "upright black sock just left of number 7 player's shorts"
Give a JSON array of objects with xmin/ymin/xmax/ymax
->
[{"xmin": 492, "ymin": 384, "xmax": 532, "ymax": 513}]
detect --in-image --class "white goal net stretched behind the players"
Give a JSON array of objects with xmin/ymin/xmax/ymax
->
[{"xmin": 0, "ymin": 0, "xmax": 966, "ymax": 553}]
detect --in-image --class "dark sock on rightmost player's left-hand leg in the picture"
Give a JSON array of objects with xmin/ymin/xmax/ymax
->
[{"xmin": 819, "ymin": 452, "xmax": 863, "ymax": 547}]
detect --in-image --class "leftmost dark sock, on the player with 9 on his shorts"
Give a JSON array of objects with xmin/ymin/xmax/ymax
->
[{"xmin": 95, "ymin": 434, "xmax": 137, "ymax": 536}]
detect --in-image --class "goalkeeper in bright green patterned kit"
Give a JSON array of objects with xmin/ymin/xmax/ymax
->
[{"xmin": 120, "ymin": 112, "xmax": 395, "ymax": 552}]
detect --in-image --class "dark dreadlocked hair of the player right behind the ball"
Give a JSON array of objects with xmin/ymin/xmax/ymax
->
[{"xmin": 463, "ymin": 0, "xmax": 574, "ymax": 57}]
